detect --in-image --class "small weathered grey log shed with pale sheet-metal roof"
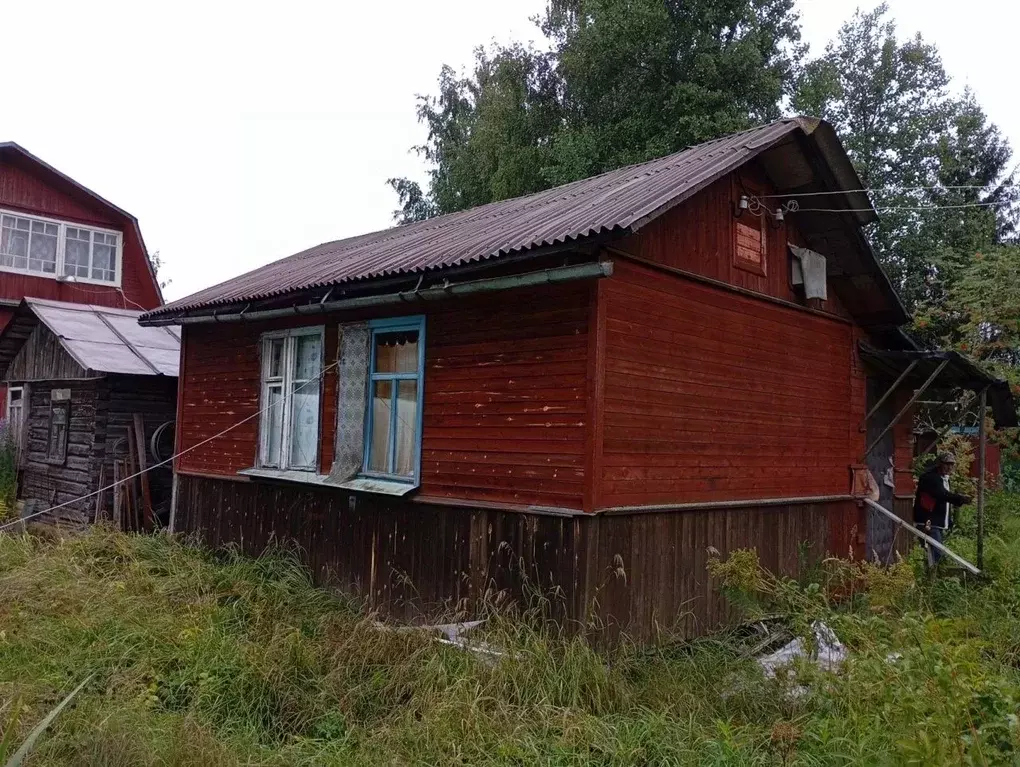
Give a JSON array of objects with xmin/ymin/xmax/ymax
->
[{"xmin": 0, "ymin": 298, "xmax": 181, "ymax": 526}]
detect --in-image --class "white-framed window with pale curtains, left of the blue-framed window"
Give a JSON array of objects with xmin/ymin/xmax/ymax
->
[{"xmin": 259, "ymin": 326, "xmax": 323, "ymax": 471}]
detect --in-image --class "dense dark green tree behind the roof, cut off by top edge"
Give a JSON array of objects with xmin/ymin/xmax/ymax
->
[{"xmin": 542, "ymin": 0, "xmax": 801, "ymax": 183}]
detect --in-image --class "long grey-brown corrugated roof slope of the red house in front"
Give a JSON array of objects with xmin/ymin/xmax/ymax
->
[{"xmin": 145, "ymin": 117, "xmax": 818, "ymax": 317}]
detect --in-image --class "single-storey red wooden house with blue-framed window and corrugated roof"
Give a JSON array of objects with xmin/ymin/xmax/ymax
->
[{"xmin": 140, "ymin": 118, "xmax": 1015, "ymax": 636}]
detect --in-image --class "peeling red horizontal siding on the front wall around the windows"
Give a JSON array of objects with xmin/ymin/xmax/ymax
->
[{"xmin": 179, "ymin": 284, "xmax": 591, "ymax": 509}]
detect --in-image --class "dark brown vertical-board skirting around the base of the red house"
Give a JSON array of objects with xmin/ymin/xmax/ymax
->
[{"xmin": 175, "ymin": 474, "xmax": 864, "ymax": 640}]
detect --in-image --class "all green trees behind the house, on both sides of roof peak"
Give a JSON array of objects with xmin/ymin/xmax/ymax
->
[{"xmin": 390, "ymin": 0, "xmax": 1020, "ymax": 432}]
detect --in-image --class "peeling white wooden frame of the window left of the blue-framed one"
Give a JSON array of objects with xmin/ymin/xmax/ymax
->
[{"xmin": 257, "ymin": 325, "xmax": 325, "ymax": 472}]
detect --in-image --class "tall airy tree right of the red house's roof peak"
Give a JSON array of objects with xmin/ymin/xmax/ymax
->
[{"xmin": 793, "ymin": 5, "xmax": 1016, "ymax": 312}]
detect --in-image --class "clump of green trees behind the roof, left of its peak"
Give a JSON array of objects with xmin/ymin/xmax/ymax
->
[{"xmin": 390, "ymin": 0, "xmax": 801, "ymax": 222}]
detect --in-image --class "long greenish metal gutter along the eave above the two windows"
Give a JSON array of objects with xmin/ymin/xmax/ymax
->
[{"xmin": 164, "ymin": 261, "xmax": 613, "ymax": 325}]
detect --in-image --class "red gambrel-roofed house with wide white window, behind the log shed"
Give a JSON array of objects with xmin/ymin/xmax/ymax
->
[{"xmin": 0, "ymin": 142, "xmax": 163, "ymax": 432}]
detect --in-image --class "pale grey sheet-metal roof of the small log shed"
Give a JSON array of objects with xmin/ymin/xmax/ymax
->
[{"xmin": 24, "ymin": 298, "xmax": 181, "ymax": 376}]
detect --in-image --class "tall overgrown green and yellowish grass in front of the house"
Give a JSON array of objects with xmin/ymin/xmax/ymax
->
[{"xmin": 0, "ymin": 497, "xmax": 1020, "ymax": 767}]
